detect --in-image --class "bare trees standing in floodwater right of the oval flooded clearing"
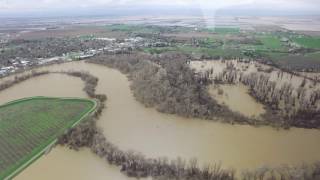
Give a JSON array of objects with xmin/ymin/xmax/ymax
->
[{"xmin": 211, "ymin": 63, "xmax": 320, "ymax": 128}]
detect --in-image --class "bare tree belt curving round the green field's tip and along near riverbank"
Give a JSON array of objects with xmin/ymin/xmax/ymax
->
[{"xmin": 54, "ymin": 72, "xmax": 234, "ymax": 180}]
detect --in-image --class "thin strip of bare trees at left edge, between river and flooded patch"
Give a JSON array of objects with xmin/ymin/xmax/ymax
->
[{"xmin": 0, "ymin": 71, "xmax": 49, "ymax": 91}]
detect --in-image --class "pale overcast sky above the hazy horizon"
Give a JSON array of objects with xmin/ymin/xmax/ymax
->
[{"xmin": 0, "ymin": 0, "xmax": 320, "ymax": 14}]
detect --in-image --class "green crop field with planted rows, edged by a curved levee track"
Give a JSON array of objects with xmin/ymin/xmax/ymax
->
[{"xmin": 0, "ymin": 97, "xmax": 96, "ymax": 179}]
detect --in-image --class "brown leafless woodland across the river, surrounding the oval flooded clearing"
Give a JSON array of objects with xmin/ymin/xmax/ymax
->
[{"xmin": 88, "ymin": 53, "xmax": 320, "ymax": 128}]
